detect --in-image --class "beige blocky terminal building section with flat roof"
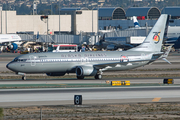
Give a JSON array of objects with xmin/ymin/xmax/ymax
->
[{"xmin": 0, "ymin": 10, "xmax": 98, "ymax": 35}]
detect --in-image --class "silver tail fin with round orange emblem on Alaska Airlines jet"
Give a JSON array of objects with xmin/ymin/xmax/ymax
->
[{"xmin": 129, "ymin": 14, "xmax": 169, "ymax": 52}]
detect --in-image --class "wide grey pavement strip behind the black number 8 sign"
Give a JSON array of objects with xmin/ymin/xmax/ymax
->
[{"xmin": 0, "ymin": 86, "xmax": 180, "ymax": 107}]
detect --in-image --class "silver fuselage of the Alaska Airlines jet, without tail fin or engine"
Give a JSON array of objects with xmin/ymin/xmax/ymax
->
[{"xmin": 7, "ymin": 51, "xmax": 152, "ymax": 73}]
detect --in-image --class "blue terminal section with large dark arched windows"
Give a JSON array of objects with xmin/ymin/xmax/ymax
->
[{"xmin": 98, "ymin": 7, "xmax": 180, "ymax": 30}]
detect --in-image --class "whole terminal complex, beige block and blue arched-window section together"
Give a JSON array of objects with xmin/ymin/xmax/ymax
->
[{"xmin": 0, "ymin": 7, "xmax": 180, "ymax": 35}]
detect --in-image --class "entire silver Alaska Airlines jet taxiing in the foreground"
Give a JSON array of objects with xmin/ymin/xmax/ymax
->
[{"xmin": 6, "ymin": 14, "xmax": 169, "ymax": 80}]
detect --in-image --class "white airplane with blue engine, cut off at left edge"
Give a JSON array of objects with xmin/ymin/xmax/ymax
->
[{"xmin": 0, "ymin": 34, "xmax": 22, "ymax": 50}]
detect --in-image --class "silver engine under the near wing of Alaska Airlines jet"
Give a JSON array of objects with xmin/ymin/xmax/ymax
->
[{"xmin": 76, "ymin": 66, "xmax": 97, "ymax": 76}]
